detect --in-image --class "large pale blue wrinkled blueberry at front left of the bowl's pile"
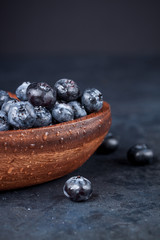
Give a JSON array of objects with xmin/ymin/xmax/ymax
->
[{"xmin": 8, "ymin": 101, "xmax": 36, "ymax": 129}]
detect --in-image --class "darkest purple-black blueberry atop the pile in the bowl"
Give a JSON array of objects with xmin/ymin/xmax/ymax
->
[{"xmin": 27, "ymin": 82, "xmax": 56, "ymax": 109}]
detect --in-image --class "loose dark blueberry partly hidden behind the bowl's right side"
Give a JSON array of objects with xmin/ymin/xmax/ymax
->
[{"xmin": 96, "ymin": 133, "xmax": 119, "ymax": 154}]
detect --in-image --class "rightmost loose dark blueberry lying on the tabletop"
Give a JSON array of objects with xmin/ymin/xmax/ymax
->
[{"xmin": 127, "ymin": 144, "xmax": 154, "ymax": 165}]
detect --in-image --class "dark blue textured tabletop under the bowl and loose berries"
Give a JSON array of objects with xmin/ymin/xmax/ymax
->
[{"xmin": 0, "ymin": 56, "xmax": 160, "ymax": 240}]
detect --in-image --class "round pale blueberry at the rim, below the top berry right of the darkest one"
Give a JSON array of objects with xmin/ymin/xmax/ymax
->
[{"xmin": 52, "ymin": 103, "xmax": 74, "ymax": 123}]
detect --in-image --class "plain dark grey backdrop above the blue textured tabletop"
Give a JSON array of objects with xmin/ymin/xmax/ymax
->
[{"xmin": 0, "ymin": 0, "xmax": 160, "ymax": 55}]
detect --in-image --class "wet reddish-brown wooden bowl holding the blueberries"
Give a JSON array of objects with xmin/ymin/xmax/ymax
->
[{"xmin": 0, "ymin": 96, "xmax": 111, "ymax": 190}]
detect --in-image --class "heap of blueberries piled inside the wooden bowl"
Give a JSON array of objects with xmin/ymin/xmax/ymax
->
[{"xmin": 0, "ymin": 79, "xmax": 103, "ymax": 131}]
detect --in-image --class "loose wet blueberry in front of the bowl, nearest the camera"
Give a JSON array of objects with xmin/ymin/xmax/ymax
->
[{"xmin": 63, "ymin": 176, "xmax": 92, "ymax": 202}]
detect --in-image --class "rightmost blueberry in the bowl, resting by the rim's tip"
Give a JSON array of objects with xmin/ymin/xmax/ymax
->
[{"xmin": 81, "ymin": 88, "xmax": 103, "ymax": 113}]
